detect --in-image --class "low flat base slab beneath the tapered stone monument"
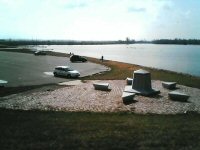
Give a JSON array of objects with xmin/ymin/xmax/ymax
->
[{"xmin": 124, "ymin": 86, "xmax": 160, "ymax": 96}]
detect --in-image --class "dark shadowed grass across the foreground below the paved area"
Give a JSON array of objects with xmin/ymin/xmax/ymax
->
[{"xmin": 0, "ymin": 109, "xmax": 200, "ymax": 150}]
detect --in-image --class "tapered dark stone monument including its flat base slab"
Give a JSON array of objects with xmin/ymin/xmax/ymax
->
[{"xmin": 124, "ymin": 69, "xmax": 160, "ymax": 96}]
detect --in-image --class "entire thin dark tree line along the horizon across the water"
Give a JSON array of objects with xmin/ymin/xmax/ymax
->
[{"xmin": 0, "ymin": 38, "xmax": 200, "ymax": 46}]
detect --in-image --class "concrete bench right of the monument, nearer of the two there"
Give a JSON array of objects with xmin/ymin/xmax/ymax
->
[{"xmin": 168, "ymin": 91, "xmax": 190, "ymax": 102}]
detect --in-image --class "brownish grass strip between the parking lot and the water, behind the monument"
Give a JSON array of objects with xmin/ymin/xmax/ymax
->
[{"xmin": 83, "ymin": 58, "xmax": 200, "ymax": 88}]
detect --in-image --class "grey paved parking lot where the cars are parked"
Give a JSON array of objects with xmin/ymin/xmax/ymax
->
[{"xmin": 0, "ymin": 52, "xmax": 107, "ymax": 87}]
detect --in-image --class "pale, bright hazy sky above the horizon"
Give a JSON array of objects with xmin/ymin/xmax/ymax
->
[{"xmin": 0, "ymin": 0, "xmax": 200, "ymax": 41}]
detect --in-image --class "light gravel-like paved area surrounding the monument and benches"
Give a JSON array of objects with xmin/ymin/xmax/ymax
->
[{"xmin": 0, "ymin": 80, "xmax": 200, "ymax": 114}]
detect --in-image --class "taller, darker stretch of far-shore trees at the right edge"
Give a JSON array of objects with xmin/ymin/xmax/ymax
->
[{"xmin": 152, "ymin": 39, "xmax": 200, "ymax": 45}]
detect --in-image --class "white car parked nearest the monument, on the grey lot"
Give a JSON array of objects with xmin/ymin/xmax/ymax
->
[{"xmin": 53, "ymin": 66, "xmax": 80, "ymax": 78}]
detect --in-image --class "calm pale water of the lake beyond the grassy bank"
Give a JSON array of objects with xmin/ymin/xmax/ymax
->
[{"xmin": 34, "ymin": 44, "xmax": 200, "ymax": 76}]
